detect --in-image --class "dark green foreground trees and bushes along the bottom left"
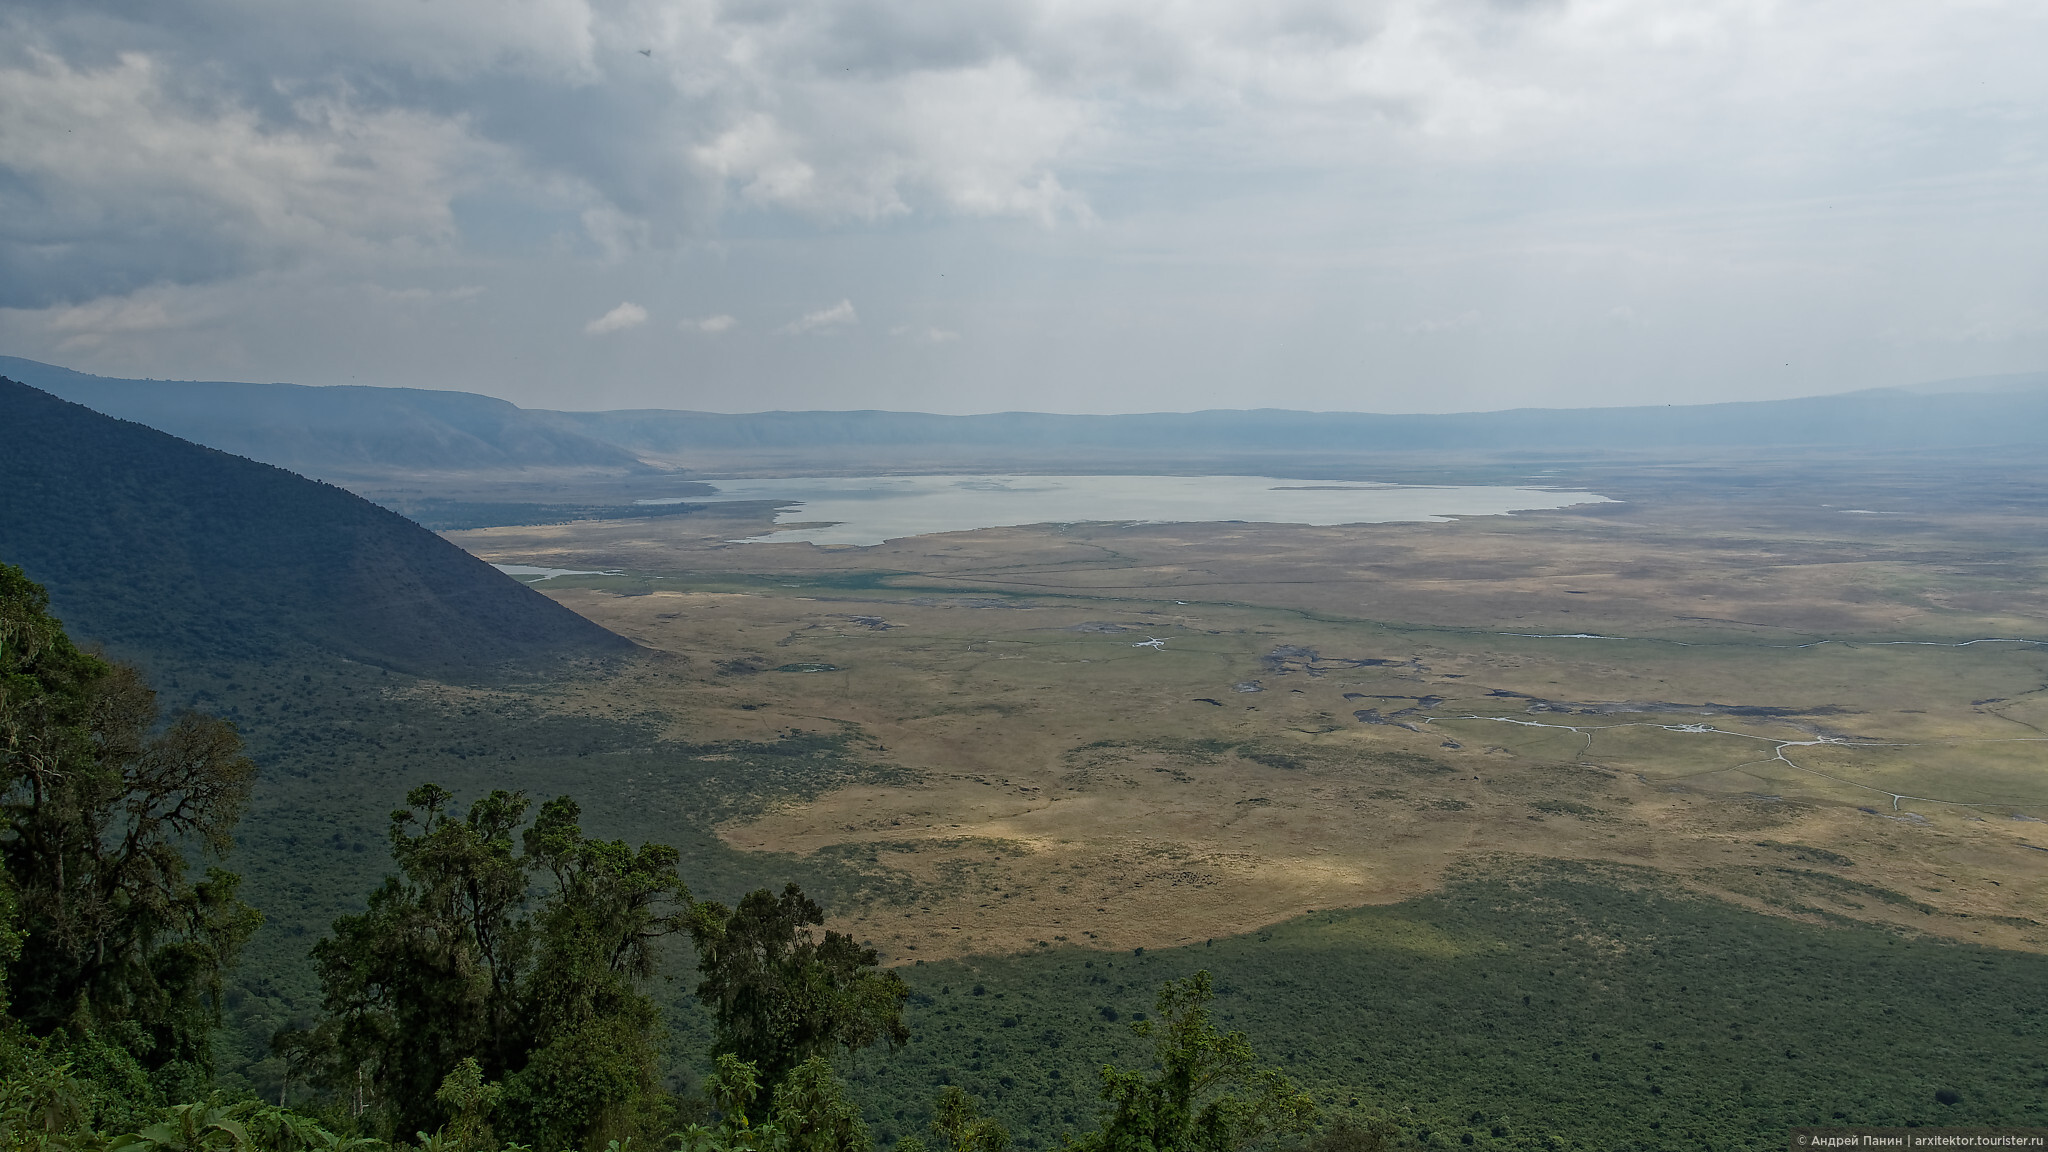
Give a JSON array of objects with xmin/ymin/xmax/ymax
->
[{"xmin": 0, "ymin": 566, "xmax": 1313, "ymax": 1152}]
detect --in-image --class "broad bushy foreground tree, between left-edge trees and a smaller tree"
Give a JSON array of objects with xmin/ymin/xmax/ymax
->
[{"xmin": 313, "ymin": 785, "xmax": 690, "ymax": 1148}]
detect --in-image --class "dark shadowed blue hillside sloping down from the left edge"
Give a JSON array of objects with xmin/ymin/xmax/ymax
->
[{"xmin": 0, "ymin": 377, "xmax": 631, "ymax": 676}]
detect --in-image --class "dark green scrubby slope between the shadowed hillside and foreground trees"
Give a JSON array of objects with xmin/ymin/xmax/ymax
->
[{"xmin": 207, "ymin": 666, "xmax": 909, "ymax": 1101}]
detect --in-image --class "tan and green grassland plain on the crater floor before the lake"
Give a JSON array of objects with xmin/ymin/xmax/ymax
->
[{"xmin": 455, "ymin": 448, "xmax": 2048, "ymax": 959}]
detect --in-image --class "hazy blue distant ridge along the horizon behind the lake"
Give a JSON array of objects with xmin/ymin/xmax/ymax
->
[{"xmin": 0, "ymin": 357, "xmax": 2048, "ymax": 480}]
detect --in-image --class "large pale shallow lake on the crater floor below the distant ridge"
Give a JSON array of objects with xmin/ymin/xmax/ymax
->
[{"xmin": 641, "ymin": 476, "xmax": 1612, "ymax": 545}]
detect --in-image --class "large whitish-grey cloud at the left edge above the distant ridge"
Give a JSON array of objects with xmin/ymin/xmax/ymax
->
[{"xmin": 0, "ymin": 51, "xmax": 544, "ymax": 305}]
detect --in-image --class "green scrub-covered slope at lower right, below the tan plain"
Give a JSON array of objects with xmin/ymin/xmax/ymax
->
[{"xmin": 848, "ymin": 861, "xmax": 2048, "ymax": 1152}]
